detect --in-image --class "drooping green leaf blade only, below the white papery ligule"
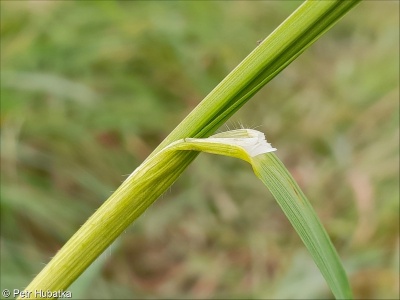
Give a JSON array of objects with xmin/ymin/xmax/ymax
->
[{"xmin": 252, "ymin": 153, "xmax": 352, "ymax": 299}]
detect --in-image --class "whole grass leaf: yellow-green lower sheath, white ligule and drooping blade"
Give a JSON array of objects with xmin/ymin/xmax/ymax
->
[{"xmin": 21, "ymin": 129, "xmax": 351, "ymax": 299}]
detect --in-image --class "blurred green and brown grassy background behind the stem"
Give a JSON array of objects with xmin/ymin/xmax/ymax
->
[{"xmin": 1, "ymin": 1, "xmax": 399, "ymax": 299}]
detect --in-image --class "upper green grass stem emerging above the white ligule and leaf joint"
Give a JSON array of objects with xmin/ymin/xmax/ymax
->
[{"xmin": 150, "ymin": 0, "xmax": 361, "ymax": 155}]
